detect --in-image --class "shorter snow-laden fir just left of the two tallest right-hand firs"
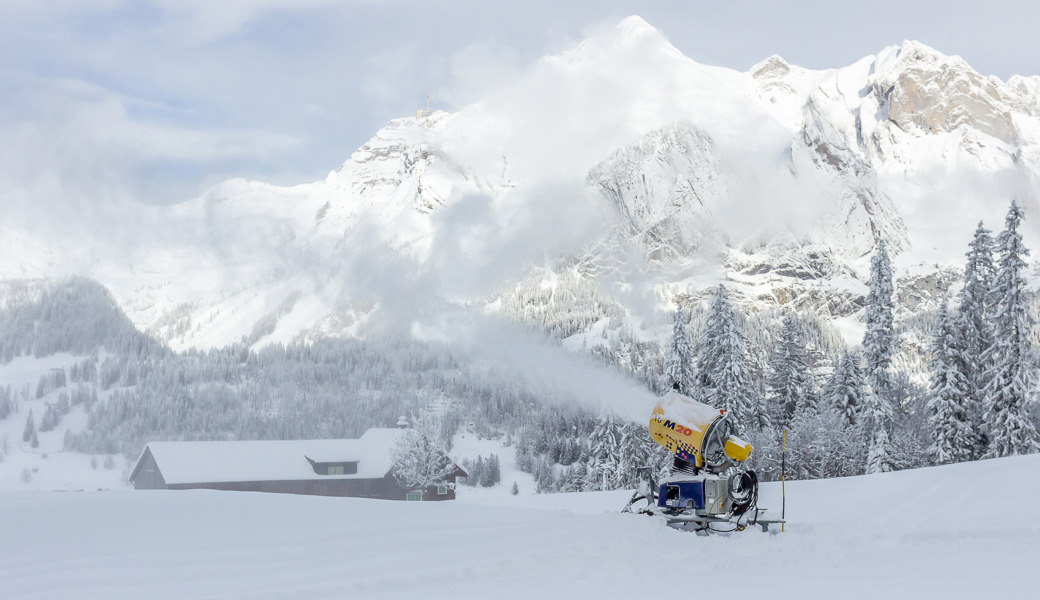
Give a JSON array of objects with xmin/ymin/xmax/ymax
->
[{"xmin": 928, "ymin": 303, "xmax": 976, "ymax": 465}]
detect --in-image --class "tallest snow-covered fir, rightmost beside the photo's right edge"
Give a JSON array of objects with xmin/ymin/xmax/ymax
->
[{"xmin": 985, "ymin": 202, "xmax": 1040, "ymax": 456}]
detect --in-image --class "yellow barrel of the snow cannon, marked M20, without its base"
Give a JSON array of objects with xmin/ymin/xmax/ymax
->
[{"xmin": 650, "ymin": 392, "xmax": 752, "ymax": 473}]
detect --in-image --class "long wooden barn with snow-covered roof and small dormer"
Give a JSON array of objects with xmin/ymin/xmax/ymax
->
[{"xmin": 130, "ymin": 428, "xmax": 466, "ymax": 500}]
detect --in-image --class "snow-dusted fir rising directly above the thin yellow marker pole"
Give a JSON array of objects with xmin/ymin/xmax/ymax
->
[{"xmin": 765, "ymin": 313, "xmax": 816, "ymax": 428}]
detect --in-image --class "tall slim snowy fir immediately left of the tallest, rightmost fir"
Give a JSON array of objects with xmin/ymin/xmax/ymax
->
[{"xmin": 958, "ymin": 221, "xmax": 996, "ymax": 459}]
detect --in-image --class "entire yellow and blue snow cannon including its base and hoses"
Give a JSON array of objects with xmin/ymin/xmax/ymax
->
[{"xmin": 622, "ymin": 392, "xmax": 783, "ymax": 534}]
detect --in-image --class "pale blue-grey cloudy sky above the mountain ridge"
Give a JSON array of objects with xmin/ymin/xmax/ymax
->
[{"xmin": 0, "ymin": 0, "xmax": 1040, "ymax": 210}]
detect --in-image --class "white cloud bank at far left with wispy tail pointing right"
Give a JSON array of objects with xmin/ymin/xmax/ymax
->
[{"xmin": 0, "ymin": 79, "xmax": 298, "ymax": 221}]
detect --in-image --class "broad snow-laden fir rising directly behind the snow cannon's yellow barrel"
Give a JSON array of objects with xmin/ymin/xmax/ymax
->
[{"xmin": 697, "ymin": 285, "xmax": 770, "ymax": 428}]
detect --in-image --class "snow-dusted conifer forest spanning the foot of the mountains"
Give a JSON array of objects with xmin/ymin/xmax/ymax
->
[{"xmin": 0, "ymin": 204, "xmax": 1040, "ymax": 492}]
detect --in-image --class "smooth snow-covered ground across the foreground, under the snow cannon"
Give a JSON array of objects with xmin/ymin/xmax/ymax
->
[{"xmin": 0, "ymin": 455, "xmax": 1040, "ymax": 600}]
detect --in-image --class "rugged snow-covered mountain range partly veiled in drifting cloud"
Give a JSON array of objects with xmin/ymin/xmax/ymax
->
[{"xmin": 0, "ymin": 17, "xmax": 1040, "ymax": 348}]
